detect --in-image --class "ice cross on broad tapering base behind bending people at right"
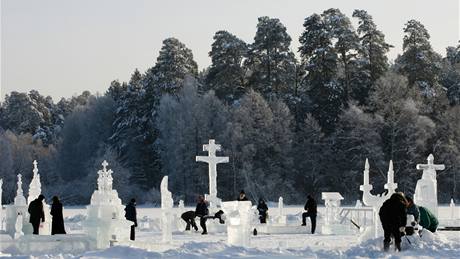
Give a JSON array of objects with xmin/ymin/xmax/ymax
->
[{"xmin": 414, "ymin": 154, "xmax": 444, "ymax": 216}]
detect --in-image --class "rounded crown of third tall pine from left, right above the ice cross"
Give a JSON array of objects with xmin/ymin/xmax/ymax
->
[{"xmin": 245, "ymin": 16, "xmax": 296, "ymax": 100}]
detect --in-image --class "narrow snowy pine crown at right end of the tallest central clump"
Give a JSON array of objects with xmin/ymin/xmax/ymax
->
[{"xmin": 351, "ymin": 10, "xmax": 392, "ymax": 105}]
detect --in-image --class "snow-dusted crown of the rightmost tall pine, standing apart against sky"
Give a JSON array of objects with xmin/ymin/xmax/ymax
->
[{"xmin": 396, "ymin": 20, "xmax": 441, "ymax": 97}]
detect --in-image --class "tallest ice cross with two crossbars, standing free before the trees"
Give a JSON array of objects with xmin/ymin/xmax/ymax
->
[{"xmin": 196, "ymin": 139, "xmax": 229, "ymax": 197}]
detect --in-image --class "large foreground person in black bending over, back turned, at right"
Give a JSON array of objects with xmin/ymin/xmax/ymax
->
[{"xmin": 379, "ymin": 192, "xmax": 407, "ymax": 251}]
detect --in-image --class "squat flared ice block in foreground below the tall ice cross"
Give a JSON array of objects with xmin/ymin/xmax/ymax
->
[{"xmin": 222, "ymin": 201, "xmax": 252, "ymax": 246}]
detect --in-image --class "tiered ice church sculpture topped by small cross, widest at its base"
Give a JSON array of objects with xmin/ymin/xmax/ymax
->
[{"xmin": 82, "ymin": 161, "xmax": 133, "ymax": 249}]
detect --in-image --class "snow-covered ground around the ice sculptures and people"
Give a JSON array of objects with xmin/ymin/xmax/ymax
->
[{"xmin": 0, "ymin": 206, "xmax": 460, "ymax": 258}]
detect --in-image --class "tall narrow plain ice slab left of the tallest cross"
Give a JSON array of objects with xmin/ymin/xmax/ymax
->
[{"xmin": 160, "ymin": 176, "xmax": 173, "ymax": 243}]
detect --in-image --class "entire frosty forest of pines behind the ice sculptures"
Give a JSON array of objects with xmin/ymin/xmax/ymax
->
[{"xmin": 0, "ymin": 9, "xmax": 460, "ymax": 204}]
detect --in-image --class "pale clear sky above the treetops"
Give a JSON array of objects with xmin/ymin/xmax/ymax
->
[{"xmin": 0, "ymin": 0, "xmax": 459, "ymax": 101}]
